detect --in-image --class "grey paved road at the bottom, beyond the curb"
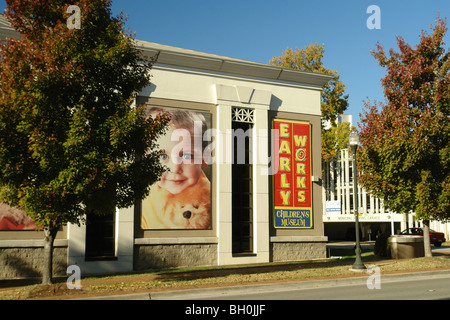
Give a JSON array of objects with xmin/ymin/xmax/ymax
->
[{"xmin": 146, "ymin": 270, "xmax": 450, "ymax": 301}]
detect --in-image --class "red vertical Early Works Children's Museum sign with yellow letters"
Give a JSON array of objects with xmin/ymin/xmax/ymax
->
[{"xmin": 273, "ymin": 120, "xmax": 312, "ymax": 228}]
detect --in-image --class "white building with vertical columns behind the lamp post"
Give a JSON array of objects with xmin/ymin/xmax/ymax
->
[{"xmin": 322, "ymin": 115, "xmax": 450, "ymax": 240}]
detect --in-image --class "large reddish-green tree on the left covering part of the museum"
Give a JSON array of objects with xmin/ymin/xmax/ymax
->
[{"xmin": 0, "ymin": 0, "xmax": 168, "ymax": 284}]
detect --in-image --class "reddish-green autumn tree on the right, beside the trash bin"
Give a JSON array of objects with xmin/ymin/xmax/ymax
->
[{"xmin": 358, "ymin": 18, "xmax": 450, "ymax": 256}]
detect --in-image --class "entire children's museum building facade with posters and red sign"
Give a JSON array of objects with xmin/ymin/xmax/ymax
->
[{"xmin": 0, "ymin": 17, "xmax": 330, "ymax": 278}]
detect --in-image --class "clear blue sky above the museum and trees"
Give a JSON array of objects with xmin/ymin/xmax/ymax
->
[{"xmin": 0, "ymin": 0, "xmax": 450, "ymax": 125}]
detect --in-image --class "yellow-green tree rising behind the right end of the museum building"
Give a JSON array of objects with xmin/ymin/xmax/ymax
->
[{"xmin": 270, "ymin": 43, "xmax": 348, "ymax": 161}]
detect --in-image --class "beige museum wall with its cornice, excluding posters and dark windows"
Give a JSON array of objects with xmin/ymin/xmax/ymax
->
[{"xmin": 0, "ymin": 24, "xmax": 329, "ymax": 274}]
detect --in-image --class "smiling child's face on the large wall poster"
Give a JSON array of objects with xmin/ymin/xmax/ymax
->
[{"xmin": 158, "ymin": 126, "xmax": 204, "ymax": 194}]
